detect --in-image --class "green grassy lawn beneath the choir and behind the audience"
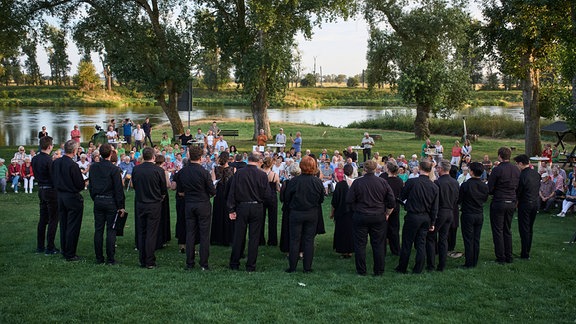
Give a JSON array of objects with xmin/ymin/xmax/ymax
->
[{"xmin": 0, "ymin": 121, "xmax": 576, "ymax": 323}]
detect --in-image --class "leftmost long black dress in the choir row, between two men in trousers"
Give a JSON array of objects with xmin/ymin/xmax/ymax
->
[{"xmin": 210, "ymin": 166, "xmax": 234, "ymax": 246}]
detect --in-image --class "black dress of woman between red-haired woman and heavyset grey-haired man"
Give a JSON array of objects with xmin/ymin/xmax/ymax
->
[{"xmin": 332, "ymin": 180, "xmax": 354, "ymax": 254}]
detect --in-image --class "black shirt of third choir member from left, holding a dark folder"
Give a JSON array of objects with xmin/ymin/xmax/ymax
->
[{"xmin": 88, "ymin": 160, "xmax": 124, "ymax": 209}]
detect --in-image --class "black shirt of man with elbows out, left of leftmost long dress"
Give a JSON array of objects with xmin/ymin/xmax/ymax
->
[{"xmin": 173, "ymin": 162, "xmax": 216, "ymax": 202}]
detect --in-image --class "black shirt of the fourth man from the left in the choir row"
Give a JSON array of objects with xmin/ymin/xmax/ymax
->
[{"xmin": 132, "ymin": 162, "xmax": 168, "ymax": 204}]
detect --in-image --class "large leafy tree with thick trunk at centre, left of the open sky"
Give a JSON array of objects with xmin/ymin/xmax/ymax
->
[{"xmin": 199, "ymin": 0, "xmax": 354, "ymax": 138}]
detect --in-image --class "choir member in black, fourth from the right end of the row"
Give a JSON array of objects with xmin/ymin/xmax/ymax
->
[{"xmin": 426, "ymin": 160, "xmax": 460, "ymax": 271}]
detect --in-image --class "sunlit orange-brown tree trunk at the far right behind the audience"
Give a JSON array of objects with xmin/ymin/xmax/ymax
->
[{"xmin": 522, "ymin": 55, "xmax": 542, "ymax": 156}]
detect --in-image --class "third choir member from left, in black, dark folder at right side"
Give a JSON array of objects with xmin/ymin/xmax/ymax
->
[{"xmin": 88, "ymin": 143, "xmax": 126, "ymax": 265}]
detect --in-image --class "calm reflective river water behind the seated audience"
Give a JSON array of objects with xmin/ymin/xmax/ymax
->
[{"xmin": 0, "ymin": 106, "xmax": 523, "ymax": 146}]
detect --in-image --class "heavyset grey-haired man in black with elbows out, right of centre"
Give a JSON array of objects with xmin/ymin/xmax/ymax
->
[{"xmin": 346, "ymin": 160, "xmax": 396, "ymax": 276}]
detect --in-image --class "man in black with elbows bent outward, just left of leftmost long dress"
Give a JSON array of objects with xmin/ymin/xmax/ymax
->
[{"xmin": 171, "ymin": 146, "xmax": 216, "ymax": 270}]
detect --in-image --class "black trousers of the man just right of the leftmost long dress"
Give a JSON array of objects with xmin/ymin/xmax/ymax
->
[{"xmin": 230, "ymin": 203, "xmax": 264, "ymax": 271}]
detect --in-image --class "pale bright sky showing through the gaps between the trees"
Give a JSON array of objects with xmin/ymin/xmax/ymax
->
[{"xmin": 37, "ymin": 0, "xmax": 481, "ymax": 76}]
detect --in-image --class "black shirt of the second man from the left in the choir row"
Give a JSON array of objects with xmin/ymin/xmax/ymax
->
[{"xmin": 51, "ymin": 155, "xmax": 84, "ymax": 193}]
